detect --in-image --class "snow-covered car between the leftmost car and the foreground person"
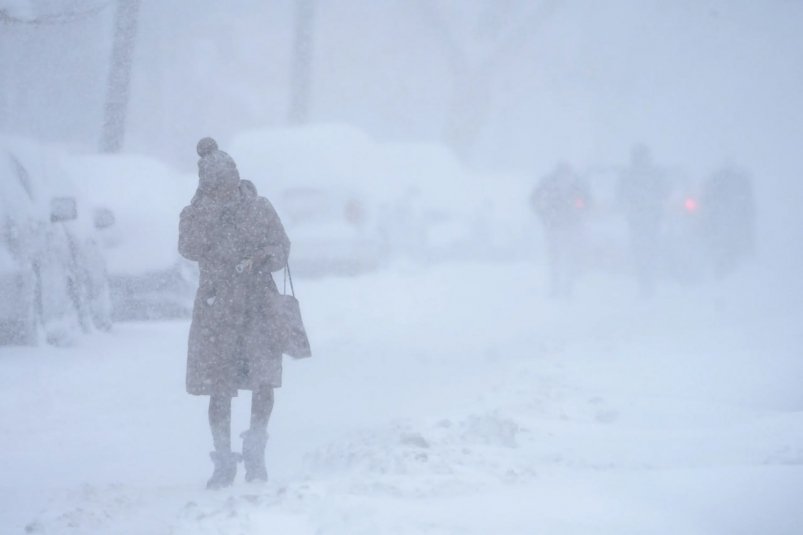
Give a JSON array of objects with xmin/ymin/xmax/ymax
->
[{"xmin": 66, "ymin": 155, "xmax": 198, "ymax": 321}]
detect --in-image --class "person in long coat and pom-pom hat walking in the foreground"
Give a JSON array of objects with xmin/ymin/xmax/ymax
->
[{"xmin": 178, "ymin": 138, "xmax": 290, "ymax": 488}]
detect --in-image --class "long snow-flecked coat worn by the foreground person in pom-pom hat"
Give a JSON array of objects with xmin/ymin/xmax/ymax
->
[{"xmin": 178, "ymin": 180, "xmax": 290, "ymax": 396}]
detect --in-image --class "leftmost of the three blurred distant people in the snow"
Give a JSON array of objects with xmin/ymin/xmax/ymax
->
[{"xmin": 530, "ymin": 163, "xmax": 589, "ymax": 297}]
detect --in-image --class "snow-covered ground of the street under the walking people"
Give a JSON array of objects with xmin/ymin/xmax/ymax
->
[{"xmin": 0, "ymin": 263, "xmax": 803, "ymax": 535}]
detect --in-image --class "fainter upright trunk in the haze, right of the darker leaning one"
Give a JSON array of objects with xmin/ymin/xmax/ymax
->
[{"xmin": 287, "ymin": 0, "xmax": 316, "ymax": 124}]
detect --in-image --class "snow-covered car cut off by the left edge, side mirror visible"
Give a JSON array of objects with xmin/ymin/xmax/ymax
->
[{"xmin": 0, "ymin": 138, "xmax": 111, "ymax": 345}]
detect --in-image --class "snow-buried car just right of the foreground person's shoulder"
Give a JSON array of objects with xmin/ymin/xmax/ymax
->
[{"xmin": 229, "ymin": 127, "xmax": 384, "ymax": 276}]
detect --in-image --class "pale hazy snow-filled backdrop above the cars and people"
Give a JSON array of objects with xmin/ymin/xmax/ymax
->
[{"xmin": 0, "ymin": 0, "xmax": 803, "ymax": 278}]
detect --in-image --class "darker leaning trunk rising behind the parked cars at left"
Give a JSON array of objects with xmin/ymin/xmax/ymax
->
[{"xmin": 100, "ymin": 0, "xmax": 140, "ymax": 152}]
